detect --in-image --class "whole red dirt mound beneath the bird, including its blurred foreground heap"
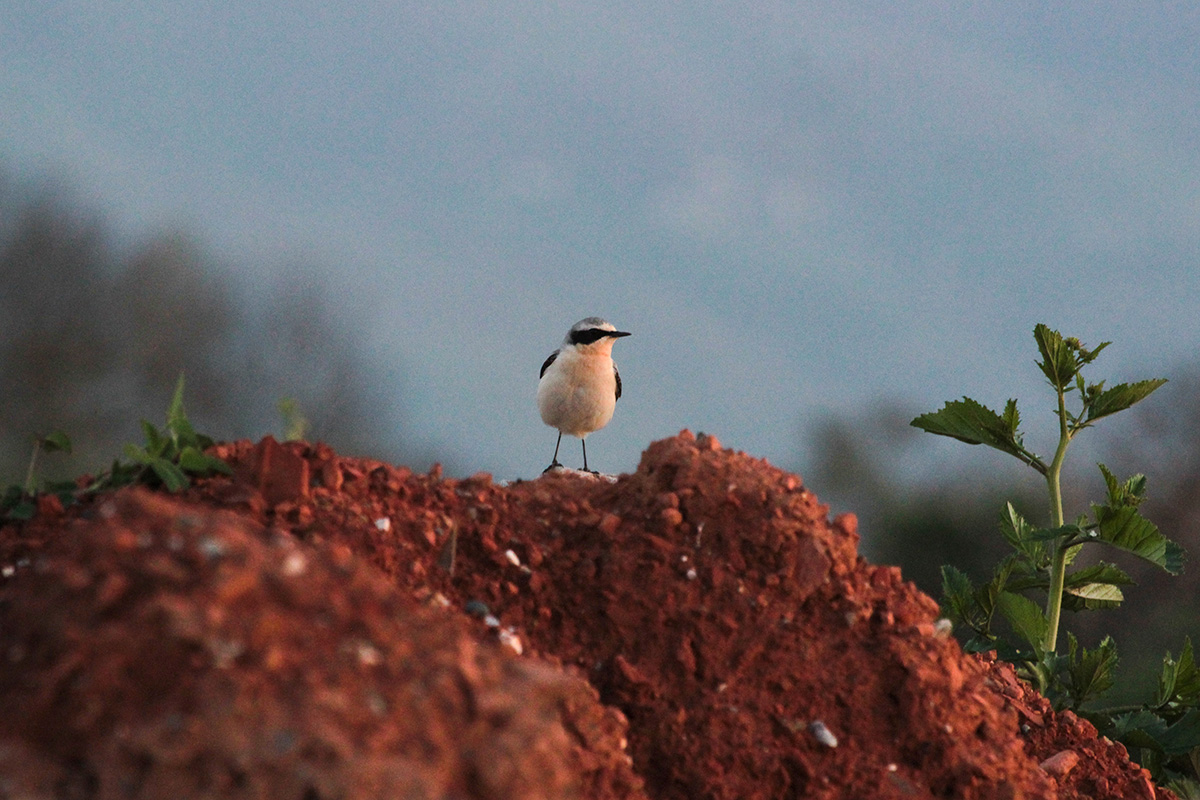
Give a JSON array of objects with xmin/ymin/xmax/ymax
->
[{"xmin": 0, "ymin": 432, "xmax": 1171, "ymax": 800}]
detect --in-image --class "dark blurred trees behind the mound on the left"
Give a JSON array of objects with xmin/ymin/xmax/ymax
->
[{"xmin": 0, "ymin": 165, "xmax": 439, "ymax": 485}]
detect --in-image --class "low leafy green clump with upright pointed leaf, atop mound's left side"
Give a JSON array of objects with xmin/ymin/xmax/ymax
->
[{"xmin": 88, "ymin": 374, "xmax": 232, "ymax": 492}]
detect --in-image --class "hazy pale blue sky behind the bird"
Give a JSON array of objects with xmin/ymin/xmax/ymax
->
[{"xmin": 0, "ymin": 0, "xmax": 1200, "ymax": 479}]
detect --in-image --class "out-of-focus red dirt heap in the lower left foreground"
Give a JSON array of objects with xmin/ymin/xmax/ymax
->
[{"xmin": 0, "ymin": 489, "xmax": 640, "ymax": 799}]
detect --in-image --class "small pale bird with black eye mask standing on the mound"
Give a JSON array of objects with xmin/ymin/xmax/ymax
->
[{"xmin": 538, "ymin": 317, "xmax": 629, "ymax": 473}]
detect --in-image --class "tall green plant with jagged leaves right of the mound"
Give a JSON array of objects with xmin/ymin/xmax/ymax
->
[{"xmin": 912, "ymin": 325, "xmax": 1200, "ymax": 788}]
